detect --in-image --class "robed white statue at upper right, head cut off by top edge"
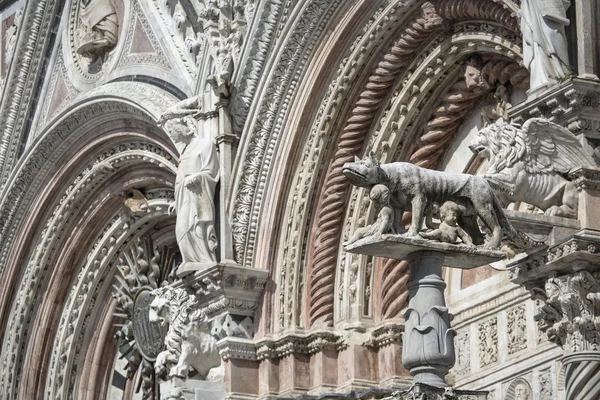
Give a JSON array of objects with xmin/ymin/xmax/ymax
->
[{"xmin": 520, "ymin": 0, "xmax": 571, "ymax": 89}]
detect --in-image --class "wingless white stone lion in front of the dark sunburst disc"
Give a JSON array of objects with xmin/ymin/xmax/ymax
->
[{"xmin": 149, "ymin": 287, "xmax": 224, "ymax": 382}]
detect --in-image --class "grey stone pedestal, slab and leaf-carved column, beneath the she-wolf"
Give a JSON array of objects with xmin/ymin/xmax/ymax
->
[{"xmin": 346, "ymin": 235, "xmax": 505, "ymax": 388}]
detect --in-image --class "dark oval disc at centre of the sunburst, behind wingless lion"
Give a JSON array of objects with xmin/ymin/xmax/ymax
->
[{"xmin": 133, "ymin": 288, "xmax": 168, "ymax": 362}]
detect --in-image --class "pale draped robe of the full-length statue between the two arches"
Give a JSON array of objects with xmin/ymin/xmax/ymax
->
[{"xmin": 175, "ymin": 136, "xmax": 219, "ymax": 263}]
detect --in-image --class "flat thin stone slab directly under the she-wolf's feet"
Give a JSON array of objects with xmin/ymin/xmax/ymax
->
[{"xmin": 346, "ymin": 235, "xmax": 506, "ymax": 269}]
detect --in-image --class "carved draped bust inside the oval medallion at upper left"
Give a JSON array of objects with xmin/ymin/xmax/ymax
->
[{"xmin": 77, "ymin": 0, "xmax": 119, "ymax": 60}]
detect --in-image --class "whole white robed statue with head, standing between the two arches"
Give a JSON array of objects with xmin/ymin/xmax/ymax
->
[{"xmin": 159, "ymin": 98, "xmax": 219, "ymax": 271}]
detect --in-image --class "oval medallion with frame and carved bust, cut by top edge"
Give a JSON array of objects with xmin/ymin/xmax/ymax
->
[{"xmin": 68, "ymin": 0, "xmax": 125, "ymax": 82}]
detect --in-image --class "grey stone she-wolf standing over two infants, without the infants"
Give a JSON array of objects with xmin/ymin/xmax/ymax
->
[{"xmin": 342, "ymin": 152, "xmax": 528, "ymax": 249}]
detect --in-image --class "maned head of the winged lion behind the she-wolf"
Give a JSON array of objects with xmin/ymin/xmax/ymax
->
[{"xmin": 469, "ymin": 123, "xmax": 526, "ymax": 174}]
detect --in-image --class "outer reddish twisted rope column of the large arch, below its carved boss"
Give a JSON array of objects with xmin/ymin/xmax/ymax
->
[{"xmin": 309, "ymin": 3, "xmax": 442, "ymax": 326}]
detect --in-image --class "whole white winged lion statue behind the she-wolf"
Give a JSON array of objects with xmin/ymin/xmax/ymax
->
[{"xmin": 469, "ymin": 118, "xmax": 595, "ymax": 218}]
